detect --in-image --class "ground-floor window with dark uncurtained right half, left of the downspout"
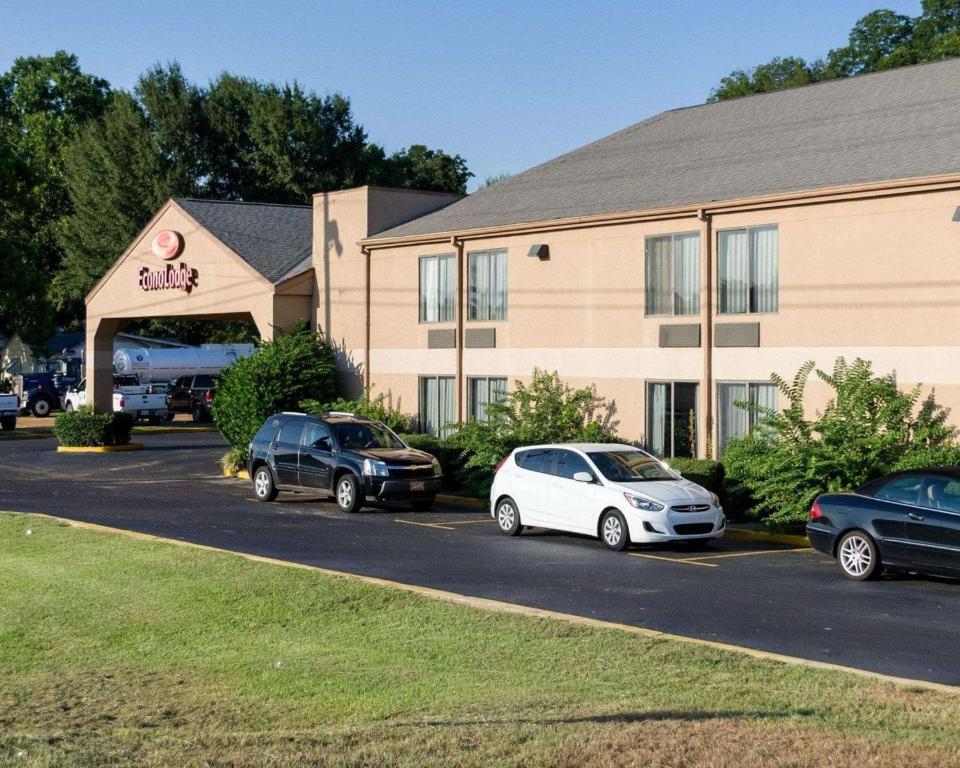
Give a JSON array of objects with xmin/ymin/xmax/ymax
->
[{"xmin": 646, "ymin": 381, "xmax": 699, "ymax": 458}]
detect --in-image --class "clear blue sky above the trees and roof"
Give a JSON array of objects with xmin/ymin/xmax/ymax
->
[{"xmin": 0, "ymin": 0, "xmax": 920, "ymax": 188}]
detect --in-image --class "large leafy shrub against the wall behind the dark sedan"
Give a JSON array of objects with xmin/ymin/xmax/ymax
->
[{"xmin": 723, "ymin": 357, "xmax": 960, "ymax": 529}]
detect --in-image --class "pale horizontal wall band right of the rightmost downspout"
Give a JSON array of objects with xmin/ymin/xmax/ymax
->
[{"xmin": 713, "ymin": 347, "xmax": 960, "ymax": 385}]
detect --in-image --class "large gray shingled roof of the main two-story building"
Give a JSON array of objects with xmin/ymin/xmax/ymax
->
[{"xmin": 376, "ymin": 59, "xmax": 960, "ymax": 238}]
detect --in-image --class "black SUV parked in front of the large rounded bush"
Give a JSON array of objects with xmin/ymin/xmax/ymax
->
[{"xmin": 247, "ymin": 413, "xmax": 442, "ymax": 512}]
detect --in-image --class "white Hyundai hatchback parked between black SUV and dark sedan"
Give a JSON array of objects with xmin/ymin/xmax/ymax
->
[{"xmin": 490, "ymin": 443, "xmax": 726, "ymax": 550}]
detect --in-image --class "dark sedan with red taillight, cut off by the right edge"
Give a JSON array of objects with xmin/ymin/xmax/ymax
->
[{"xmin": 807, "ymin": 468, "xmax": 960, "ymax": 581}]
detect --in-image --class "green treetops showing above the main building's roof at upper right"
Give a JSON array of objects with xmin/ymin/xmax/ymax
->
[{"xmin": 708, "ymin": 0, "xmax": 960, "ymax": 101}]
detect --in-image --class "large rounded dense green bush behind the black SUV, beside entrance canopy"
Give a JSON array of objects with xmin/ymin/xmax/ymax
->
[{"xmin": 212, "ymin": 322, "xmax": 337, "ymax": 456}]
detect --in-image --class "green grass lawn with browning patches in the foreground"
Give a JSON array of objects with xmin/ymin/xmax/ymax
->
[{"xmin": 0, "ymin": 513, "xmax": 960, "ymax": 766}]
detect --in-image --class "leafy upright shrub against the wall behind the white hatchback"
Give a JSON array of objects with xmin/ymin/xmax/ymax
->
[{"xmin": 447, "ymin": 368, "xmax": 616, "ymax": 476}]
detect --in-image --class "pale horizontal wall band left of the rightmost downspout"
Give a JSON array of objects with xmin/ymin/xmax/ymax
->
[{"xmin": 370, "ymin": 347, "xmax": 703, "ymax": 381}]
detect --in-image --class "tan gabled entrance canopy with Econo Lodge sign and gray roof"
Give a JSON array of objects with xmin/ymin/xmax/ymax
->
[{"xmin": 86, "ymin": 199, "xmax": 315, "ymax": 410}]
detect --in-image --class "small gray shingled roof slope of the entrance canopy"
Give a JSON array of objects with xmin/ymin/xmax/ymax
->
[{"xmin": 176, "ymin": 198, "xmax": 313, "ymax": 283}]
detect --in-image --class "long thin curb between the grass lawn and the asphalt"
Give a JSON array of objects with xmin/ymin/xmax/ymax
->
[{"xmin": 15, "ymin": 510, "xmax": 960, "ymax": 696}]
